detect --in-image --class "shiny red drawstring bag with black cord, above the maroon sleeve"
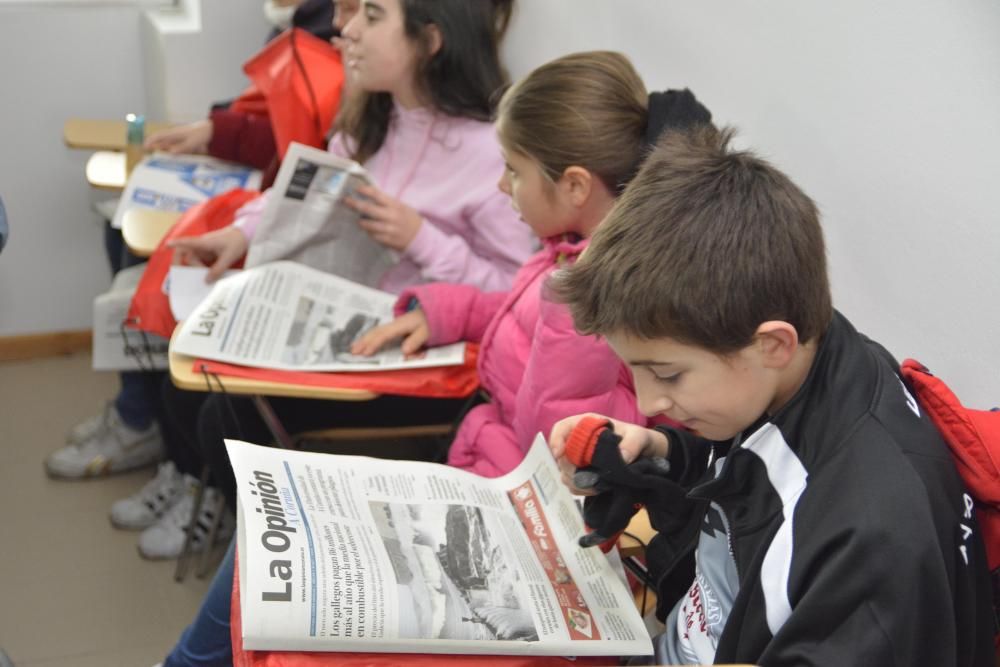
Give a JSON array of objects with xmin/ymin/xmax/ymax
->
[{"xmin": 236, "ymin": 28, "xmax": 344, "ymax": 162}]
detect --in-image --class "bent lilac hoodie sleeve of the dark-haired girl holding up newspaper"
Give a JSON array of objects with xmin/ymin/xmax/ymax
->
[{"xmin": 403, "ymin": 189, "xmax": 536, "ymax": 292}]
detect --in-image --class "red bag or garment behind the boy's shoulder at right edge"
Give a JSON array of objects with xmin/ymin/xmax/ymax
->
[{"xmin": 900, "ymin": 359, "xmax": 1000, "ymax": 570}]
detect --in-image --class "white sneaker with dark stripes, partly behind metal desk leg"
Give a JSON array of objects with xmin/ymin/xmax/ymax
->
[{"xmin": 139, "ymin": 475, "xmax": 235, "ymax": 560}]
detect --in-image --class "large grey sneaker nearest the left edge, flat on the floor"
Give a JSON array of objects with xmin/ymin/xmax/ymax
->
[{"xmin": 45, "ymin": 404, "xmax": 164, "ymax": 479}]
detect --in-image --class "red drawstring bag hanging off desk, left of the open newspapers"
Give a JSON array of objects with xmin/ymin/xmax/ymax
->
[{"xmin": 126, "ymin": 188, "xmax": 260, "ymax": 338}]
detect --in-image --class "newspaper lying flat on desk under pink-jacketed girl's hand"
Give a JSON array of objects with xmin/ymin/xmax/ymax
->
[{"xmin": 171, "ymin": 262, "xmax": 465, "ymax": 371}]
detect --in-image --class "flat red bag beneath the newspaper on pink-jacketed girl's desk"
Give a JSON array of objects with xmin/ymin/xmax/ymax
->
[{"xmin": 194, "ymin": 344, "xmax": 479, "ymax": 398}]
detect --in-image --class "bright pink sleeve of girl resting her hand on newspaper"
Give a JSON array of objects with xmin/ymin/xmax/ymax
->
[{"xmin": 395, "ymin": 283, "xmax": 507, "ymax": 347}]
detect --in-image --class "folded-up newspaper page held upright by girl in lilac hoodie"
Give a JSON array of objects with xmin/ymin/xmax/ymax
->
[{"xmin": 246, "ymin": 142, "xmax": 399, "ymax": 287}]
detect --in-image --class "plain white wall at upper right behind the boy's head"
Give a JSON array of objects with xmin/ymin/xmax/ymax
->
[{"xmin": 505, "ymin": 0, "xmax": 1000, "ymax": 407}]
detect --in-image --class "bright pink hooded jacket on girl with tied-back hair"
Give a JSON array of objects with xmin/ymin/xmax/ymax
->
[{"xmin": 396, "ymin": 237, "xmax": 646, "ymax": 477}]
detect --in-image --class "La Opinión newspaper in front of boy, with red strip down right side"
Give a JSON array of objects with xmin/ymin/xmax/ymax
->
[{"xmin": 226, "ymin": 435, "xmax": 653, "ymax": 656}]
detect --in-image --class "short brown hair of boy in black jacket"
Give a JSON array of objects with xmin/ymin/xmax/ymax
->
[{"xmin": 552, "ymin": 127, "xmax": 833, "ymax": 355}]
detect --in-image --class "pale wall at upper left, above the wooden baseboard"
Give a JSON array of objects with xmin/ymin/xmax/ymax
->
[{"xmin": 0, "ymin": 0, "xmax": 268, "ymax": 336}]
